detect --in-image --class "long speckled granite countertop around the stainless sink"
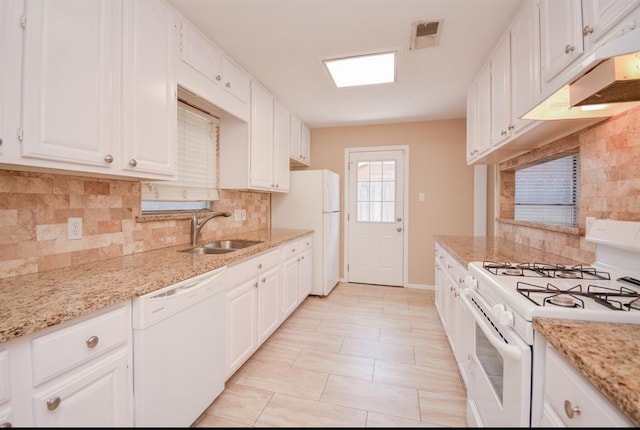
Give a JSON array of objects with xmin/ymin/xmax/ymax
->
[{"xmin": 0, "ymin": 229, "xmax": 313, "ymax": 343}]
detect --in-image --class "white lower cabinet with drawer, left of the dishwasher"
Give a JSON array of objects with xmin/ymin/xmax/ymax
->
[{"xmin": 0, "ymin": 301, "xmax": 134, "ymax": 427}]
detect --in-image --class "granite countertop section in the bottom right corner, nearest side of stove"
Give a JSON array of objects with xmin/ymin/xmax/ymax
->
[{"xmin": 533, "ymin": 318, "xmax": 640, "ymax": 426}]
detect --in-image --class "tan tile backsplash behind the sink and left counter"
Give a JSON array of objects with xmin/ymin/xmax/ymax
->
[{"xmin": 0, "ymin": 170, "xmax": 270, "ymax": 278}]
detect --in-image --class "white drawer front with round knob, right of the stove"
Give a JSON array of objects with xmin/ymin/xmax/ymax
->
[{"xmin": 545, "ymin": 345, "xmax": 632, "ymax": 427}]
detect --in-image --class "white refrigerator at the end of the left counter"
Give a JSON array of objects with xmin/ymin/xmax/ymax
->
[{"xmin": 271, "ymin": 169, "xmax": 340, "ymax": 296}]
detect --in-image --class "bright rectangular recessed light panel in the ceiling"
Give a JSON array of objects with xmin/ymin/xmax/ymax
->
[{"xmin": 322, "ymin": 52, "xmax": 397, "ymax": 88}]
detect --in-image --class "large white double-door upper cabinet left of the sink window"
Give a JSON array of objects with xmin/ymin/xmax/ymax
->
[{"xmin": 8, "ymin": 0, "xmax": 176, "ymax": 179}]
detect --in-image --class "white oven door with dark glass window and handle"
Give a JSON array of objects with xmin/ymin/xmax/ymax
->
[{"xmin": 460, "ymin": 288, "xmax": 531, "ymax": 427}]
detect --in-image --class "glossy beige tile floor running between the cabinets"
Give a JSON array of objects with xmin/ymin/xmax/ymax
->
[{"xmin": 193, "ymin": 283, "xmax": 467, "ymax": 427}]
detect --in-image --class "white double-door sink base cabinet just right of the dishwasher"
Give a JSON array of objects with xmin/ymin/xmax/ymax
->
[{"xmin": 225, "ymin": 248, "xmax": 281, "ymax": 378}]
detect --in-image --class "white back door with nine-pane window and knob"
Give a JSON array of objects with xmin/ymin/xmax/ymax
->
[{"xmin": 346, "ymin": 149, "xmax": 405, "ymax": 286}]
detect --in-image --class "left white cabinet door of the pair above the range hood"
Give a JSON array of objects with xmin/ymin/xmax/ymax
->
[{"xmin": 540, "ymin": 0, "xmax": 584, "ymax": 85}]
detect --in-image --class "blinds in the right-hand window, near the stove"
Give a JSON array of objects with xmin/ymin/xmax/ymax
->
[{"xmin": 514, "ymin": 154, "xmax": 580, "ymax": 227}]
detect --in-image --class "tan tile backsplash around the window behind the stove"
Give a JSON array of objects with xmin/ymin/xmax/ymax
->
[{"xmin": 496, "ymin": 108, "xmax": 640, "ymax": 263}]
